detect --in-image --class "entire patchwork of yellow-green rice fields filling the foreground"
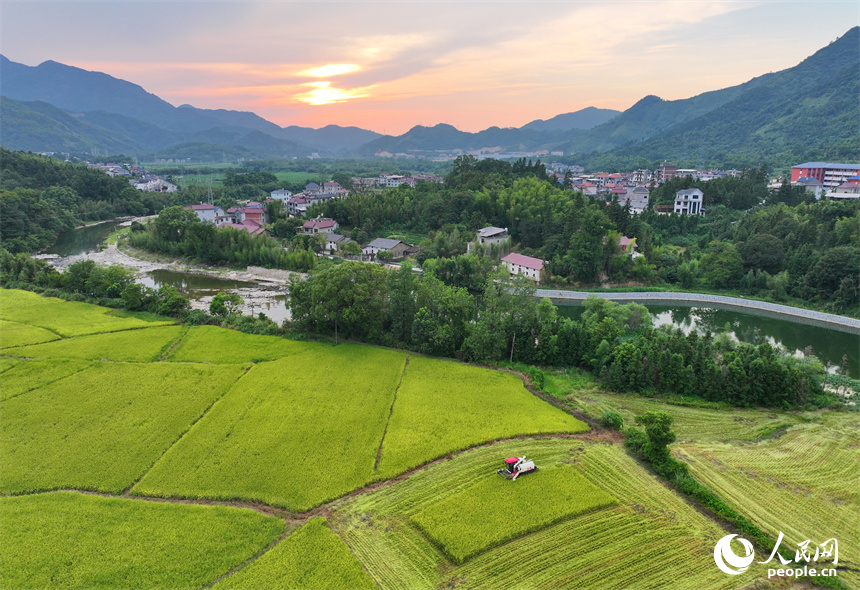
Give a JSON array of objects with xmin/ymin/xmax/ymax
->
[{"xmin": 0, "ymin": 290, "xmax": 860, "ymax": 590}]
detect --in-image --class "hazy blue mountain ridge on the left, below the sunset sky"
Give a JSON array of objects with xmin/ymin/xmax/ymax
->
[{"xmin": 0, "ymin": 56, "xmax": 379, "ymax": 157}]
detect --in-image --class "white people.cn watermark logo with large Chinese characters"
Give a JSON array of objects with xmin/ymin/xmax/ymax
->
[{"xmin": 714, "ymin": 531, "xmax": 839, "ymax": 578}]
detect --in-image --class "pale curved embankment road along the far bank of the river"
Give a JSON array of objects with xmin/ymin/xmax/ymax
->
[{"xmin": 535, "ymin": 289, "xmax": 860, "ymax": 334}]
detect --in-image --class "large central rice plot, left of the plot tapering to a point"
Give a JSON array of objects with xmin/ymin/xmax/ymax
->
[{"xmin": 133, "ymin": 345, "xmax": 406, "ymax": 510}]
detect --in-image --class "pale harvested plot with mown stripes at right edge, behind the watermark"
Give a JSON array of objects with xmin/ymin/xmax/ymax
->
[{"xmin": 672, "ymin": 412, "xmax": 860, "ymax": 587}]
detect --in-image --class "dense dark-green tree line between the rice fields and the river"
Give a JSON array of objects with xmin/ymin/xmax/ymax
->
[{"xmin": 290, "ymin": 262, "xmax": 835, "ymax": 408}]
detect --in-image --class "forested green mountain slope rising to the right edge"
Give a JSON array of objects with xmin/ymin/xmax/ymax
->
[{"xmin": 570, "ymin": 27, "xmax": 860, "ymax": 167}]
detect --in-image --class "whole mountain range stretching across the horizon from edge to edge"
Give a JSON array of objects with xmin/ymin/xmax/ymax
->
[{"xmin": 0, "ymin": 27, "xmax": 860, "ymax": 167}]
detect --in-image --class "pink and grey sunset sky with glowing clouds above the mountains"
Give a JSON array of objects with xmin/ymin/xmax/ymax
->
[{"xmin": 0, "ymin": 0, "xmax": 860, "ymax": 135}]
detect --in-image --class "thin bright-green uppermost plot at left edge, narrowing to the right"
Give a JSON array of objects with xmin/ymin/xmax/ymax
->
[{"xmin": 0, "ymin": 289, "xmax": 176, "ymax": 337}]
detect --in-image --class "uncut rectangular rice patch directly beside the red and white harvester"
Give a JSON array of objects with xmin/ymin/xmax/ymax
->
[{"xmin": 411, "ymin": 466, "xmax": 616, "ymax": 563}]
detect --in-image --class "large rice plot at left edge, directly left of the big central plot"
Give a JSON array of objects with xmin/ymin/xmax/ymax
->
[{"xmin": 0, "ymin": 363, "xmax": 245, "ymax": 494}]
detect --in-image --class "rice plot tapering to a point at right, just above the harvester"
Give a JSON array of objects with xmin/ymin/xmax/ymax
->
[{"xmin": 379, "ymin": 357, "xmax": 588, "ymax": 477}]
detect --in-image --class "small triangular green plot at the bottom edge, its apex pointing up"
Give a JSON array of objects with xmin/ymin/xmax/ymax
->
[{"xmin": 214, "ymin": 518, "xmax": 377, "ymax": 590}]
